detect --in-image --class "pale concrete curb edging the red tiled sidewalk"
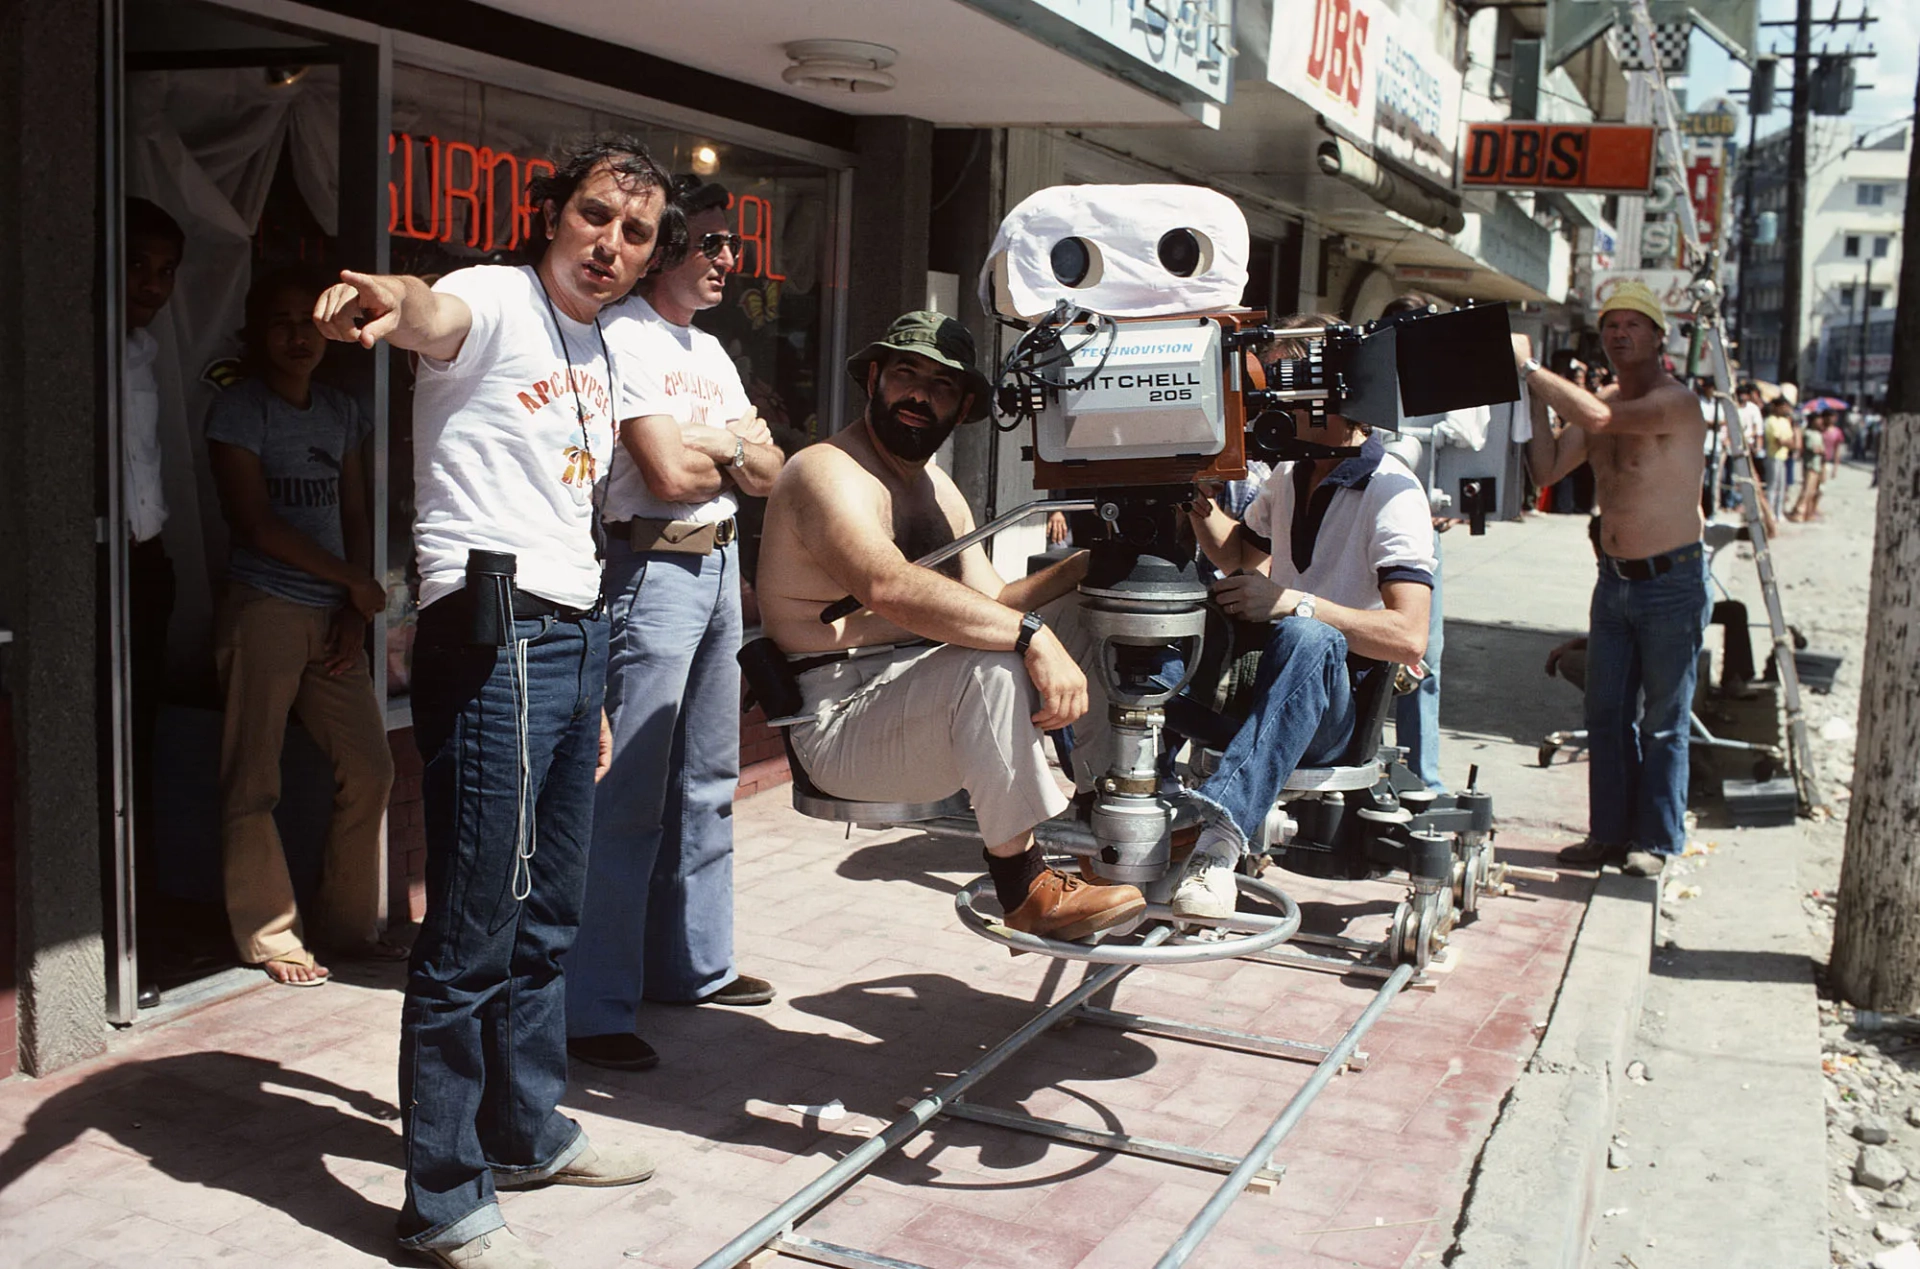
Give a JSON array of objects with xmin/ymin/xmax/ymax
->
[{"xmin": 1446, "ymin": 874, "xmax": 1659, "ymax": 1269}]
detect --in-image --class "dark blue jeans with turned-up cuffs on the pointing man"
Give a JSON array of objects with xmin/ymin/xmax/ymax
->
[{"xmin": 399, "ymin": 599, "xmax": 607, "ymax": 1248}]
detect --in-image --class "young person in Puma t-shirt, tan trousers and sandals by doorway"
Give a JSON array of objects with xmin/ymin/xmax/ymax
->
[{"xmin": 207, "ymin": 271, "xmax": 405, "ymax": 987}]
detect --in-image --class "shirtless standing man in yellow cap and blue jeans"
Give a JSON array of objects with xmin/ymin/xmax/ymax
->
[{"xmin": 1513, "ymin": 282, "xmax": 1707, "ymax": 877}]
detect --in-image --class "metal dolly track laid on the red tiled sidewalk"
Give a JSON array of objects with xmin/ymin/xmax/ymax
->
[{"xmin": 699, "ymin": 925, "xmax": 1415, "ymax": 1269}]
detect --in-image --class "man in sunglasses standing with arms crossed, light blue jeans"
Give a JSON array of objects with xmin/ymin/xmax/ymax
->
[{"xmin": 566, "ymin": 177, "xmax": 785, "ymax": 1071}]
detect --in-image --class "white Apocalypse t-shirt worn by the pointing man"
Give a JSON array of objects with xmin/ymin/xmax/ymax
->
[{"xmin": 413, "ymin": 265, "xmax": 618, "ymax": 609}]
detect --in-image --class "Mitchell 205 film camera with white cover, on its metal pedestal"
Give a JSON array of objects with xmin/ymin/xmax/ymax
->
[{"xmin": 979, "ymin": 184, "xmax": 1519, "ymax": 883}]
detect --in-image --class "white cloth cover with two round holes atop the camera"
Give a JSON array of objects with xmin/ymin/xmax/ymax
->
[{"xmin": 979, "ymin": 184, "xmax": 1246, "ymax": 323}]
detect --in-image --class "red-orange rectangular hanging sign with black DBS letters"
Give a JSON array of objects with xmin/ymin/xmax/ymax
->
[{"xmin": 1459, "ymin": 123, "xmax": 1653, "ymax": 194}]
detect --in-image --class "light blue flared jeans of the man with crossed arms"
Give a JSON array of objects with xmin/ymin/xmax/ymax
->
[{"xmin": 566, "ymin": 541, "xmax": 741, "ymax": 1035}]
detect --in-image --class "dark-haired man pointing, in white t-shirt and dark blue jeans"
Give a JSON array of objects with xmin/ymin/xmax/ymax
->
[{"xmin": 315, "ymin": 138, "xmax": 684, "ymax": 1269}]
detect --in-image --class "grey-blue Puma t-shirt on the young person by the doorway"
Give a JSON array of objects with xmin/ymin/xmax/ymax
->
[{"xmin": 207, "ymin": 378, "xmax": 367, "ymax": 609}]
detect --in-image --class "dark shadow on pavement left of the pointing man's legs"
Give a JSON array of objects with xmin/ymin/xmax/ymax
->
[{"xmin": 0, "ymin": 1052, "xmax": 401, "ymax": 1259}]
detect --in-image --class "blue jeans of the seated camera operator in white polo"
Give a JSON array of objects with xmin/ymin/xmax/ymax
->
[{"xmin": 1192, "ymin": 616, "xmax": 1356, "ymax": 847}]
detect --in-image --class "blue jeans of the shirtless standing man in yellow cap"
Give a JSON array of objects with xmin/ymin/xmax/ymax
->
[{"xmin": 1586, "ymin": 545, "xmax": 1711, "ymax": 854}]
